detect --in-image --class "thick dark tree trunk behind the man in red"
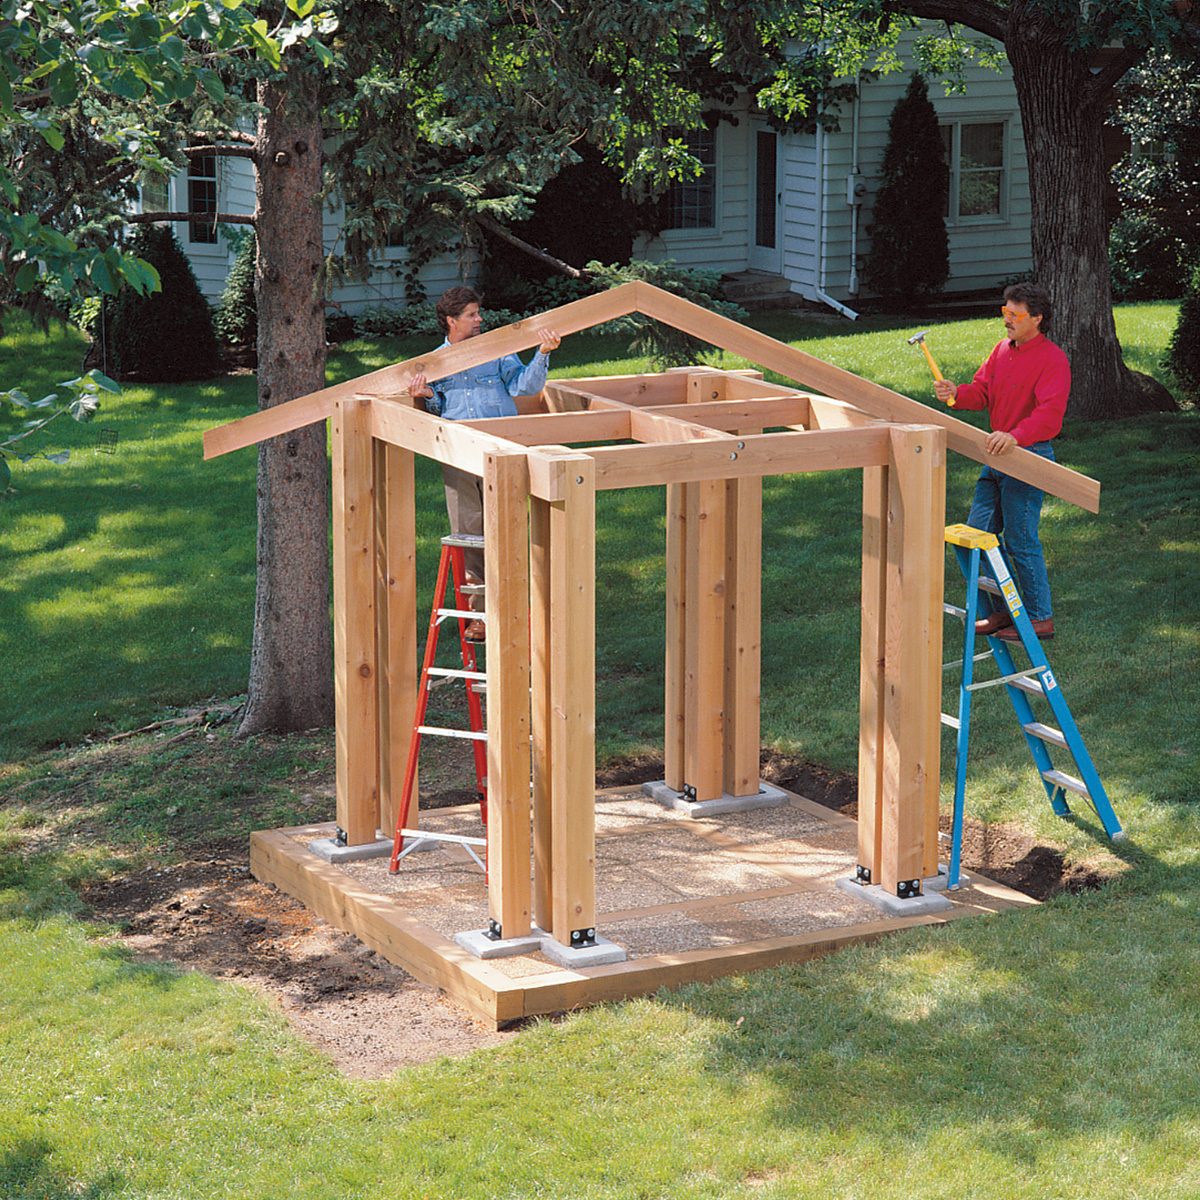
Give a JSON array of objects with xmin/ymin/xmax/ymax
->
[{"xmin": 1004, "ymin": 14, "xmax": 1176, "ymax": 420}]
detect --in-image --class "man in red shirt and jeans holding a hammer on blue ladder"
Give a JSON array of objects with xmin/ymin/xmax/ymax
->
[{"xmin": 934, "ymin": 283, "xmax": 1070, "ymax": 641}]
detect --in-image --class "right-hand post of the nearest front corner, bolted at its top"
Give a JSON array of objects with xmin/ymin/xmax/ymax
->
[{"xmin": 550, "ymin": 455, "xmax": 595, "ymax": 946}]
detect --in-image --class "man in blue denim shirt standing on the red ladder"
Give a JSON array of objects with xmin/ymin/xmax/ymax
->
[{"xmin": 408, "ymin": 287, "xmax": 560, "ymax": 642}]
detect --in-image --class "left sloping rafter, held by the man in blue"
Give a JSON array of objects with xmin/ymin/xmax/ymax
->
[{"xmin": 204, "ymin": 283, "xmax": 637, "ymax": 458}]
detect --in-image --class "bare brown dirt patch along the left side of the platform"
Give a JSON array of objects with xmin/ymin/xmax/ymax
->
[{"xmin": 83, "ymin": 848, "xmax": 512, "ymax": 1079}]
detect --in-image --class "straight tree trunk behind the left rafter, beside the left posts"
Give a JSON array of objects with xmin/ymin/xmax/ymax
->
[{"xmin": 238, "ymin": 67, "xmax": 334, "ymax": 734}]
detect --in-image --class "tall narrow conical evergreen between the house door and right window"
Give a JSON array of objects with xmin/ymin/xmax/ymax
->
[{"xmin": 863, "ymin": 74, "xmax": 950, "ymax": 305}]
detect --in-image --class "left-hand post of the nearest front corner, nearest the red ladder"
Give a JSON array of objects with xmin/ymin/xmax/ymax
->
[{"xmin": 484, "ymin": 454, "xmax": 532, "ymax": 937}]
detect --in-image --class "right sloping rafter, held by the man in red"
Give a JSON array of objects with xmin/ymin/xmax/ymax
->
[{"xmin": 633, "ymin": 281, "xmax": 1100, "ymax": 512}]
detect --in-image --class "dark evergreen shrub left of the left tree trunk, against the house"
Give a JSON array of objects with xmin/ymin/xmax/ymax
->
[{"xmin": 107, "ymin": 224, "xmax": 221, "ymax": 383}]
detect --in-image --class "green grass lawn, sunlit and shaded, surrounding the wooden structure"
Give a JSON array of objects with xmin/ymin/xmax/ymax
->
[{"xmin": 0, "ymin": 297, "xmax": 1200, "ymax": 1200}]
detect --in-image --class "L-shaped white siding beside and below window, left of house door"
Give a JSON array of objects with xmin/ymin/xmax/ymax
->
[{"xmin": 634, "ymin": 106, "xmax": 752, "ymax": 271}]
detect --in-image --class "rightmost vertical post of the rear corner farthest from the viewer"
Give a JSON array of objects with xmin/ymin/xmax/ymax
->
[{"xmin": 724, "ymin": 476, "xmax": 762, "ymax": 796}]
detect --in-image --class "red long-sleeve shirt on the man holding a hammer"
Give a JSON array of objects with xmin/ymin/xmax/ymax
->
[{"xmin": 954, "ymin": 334, "xmax": 1070, "ymax": 446}]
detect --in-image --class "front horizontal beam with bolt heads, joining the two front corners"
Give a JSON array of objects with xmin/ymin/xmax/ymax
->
[{"xmin": 576, "ymin": 426, "xmax": 889, "ymax": 494}]
